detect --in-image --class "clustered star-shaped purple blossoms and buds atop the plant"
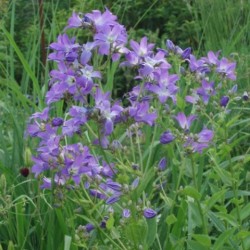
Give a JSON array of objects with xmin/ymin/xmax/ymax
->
[{"xmin": 27, "ymin": 9, "xmax": 236, "ymax": 242}]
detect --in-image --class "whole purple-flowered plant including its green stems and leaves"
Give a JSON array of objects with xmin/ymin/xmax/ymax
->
[{"xmin": 27, "ymin": 9, "xmax": 247, "ymax": 249}]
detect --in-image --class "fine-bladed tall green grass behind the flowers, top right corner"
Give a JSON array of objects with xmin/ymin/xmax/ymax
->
[{"xmin": 191, "ymin": 0, "xmax": 250, "ymax": 88}]
